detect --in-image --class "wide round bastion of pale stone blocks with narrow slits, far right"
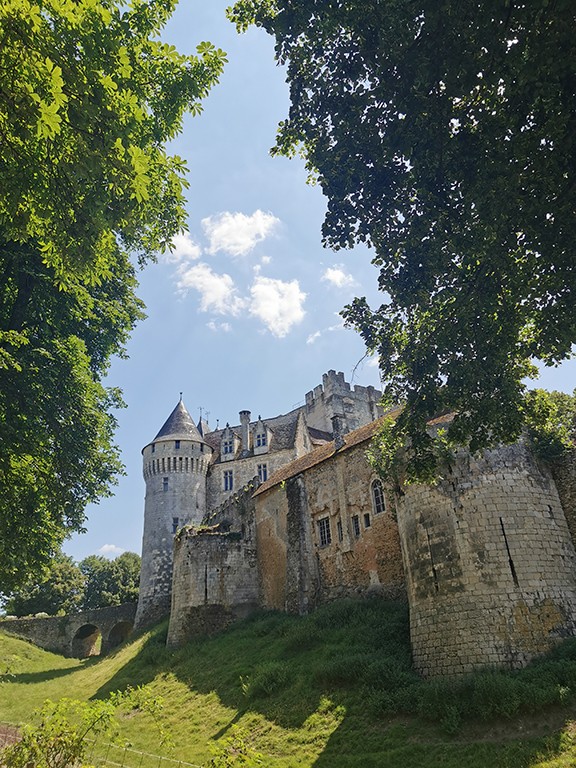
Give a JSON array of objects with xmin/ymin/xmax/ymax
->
[{"xmin": 398, "ymin": 444, "xmax": 576, "ymax": 676}]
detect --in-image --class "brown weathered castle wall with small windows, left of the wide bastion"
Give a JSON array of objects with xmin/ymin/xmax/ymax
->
[{"xmin": 256, "ymin": 444, "xmax": 405, "ymax": 613}]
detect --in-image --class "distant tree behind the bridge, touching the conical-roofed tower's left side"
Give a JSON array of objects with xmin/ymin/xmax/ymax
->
[{"xmin": 80, "ymin": 552, "xmax": 140, "ymax": 609}]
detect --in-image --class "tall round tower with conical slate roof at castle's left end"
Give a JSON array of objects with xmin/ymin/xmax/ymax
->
[{"xmin": 135, "ymin": 399, "xmax": 212, "ymax": 629}]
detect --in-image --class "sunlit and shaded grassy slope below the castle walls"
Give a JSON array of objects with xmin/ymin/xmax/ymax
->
[{"xmin": 0, "ymin": 601, "xmax": 576, "ymax": 768}]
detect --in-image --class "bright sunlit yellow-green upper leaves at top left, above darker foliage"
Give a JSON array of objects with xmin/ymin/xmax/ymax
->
[{"xmin": 0, "ymin": 0, "xmax": 225, "ymax": 284}]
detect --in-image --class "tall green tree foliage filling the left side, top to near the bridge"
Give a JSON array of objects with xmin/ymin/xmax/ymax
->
[{"xmin": 0, "ymin": 0, "xmax": 225, "ymax": 594}]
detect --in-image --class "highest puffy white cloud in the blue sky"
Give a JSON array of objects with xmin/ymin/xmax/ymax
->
[{"xmin": 202, "ymin": 210, "xmax": 280, "ymax": 256}]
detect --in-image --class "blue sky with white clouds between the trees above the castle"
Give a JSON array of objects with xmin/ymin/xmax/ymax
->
[{"xmin": 64, "ymin": 0, "xmax": 576, "ymax": 561}]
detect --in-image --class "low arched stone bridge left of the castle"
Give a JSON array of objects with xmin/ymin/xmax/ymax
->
[{"xmin": 0, "ymin": 603, "xmax": 136, "ymax": 659}]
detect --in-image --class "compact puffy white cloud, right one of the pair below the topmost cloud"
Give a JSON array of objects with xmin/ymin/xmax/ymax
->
[{"xmin": 250, "ymin": 277, "xmax": 306, "ymax": 338}]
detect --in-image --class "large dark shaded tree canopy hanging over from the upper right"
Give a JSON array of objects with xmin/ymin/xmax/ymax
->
[{"xmin": 231, "ymin": 0, "xmax": 576, "ymax": 477}]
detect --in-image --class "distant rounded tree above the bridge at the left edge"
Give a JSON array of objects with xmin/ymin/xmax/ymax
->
[{"xmin": 4, "ymin": 554, "xmax": 85, "ymax": 616}]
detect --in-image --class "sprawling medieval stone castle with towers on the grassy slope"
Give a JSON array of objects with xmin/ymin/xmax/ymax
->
[{"xmin": 136, "ymin": 371, "xmax": 576, "ymax": 676}]
